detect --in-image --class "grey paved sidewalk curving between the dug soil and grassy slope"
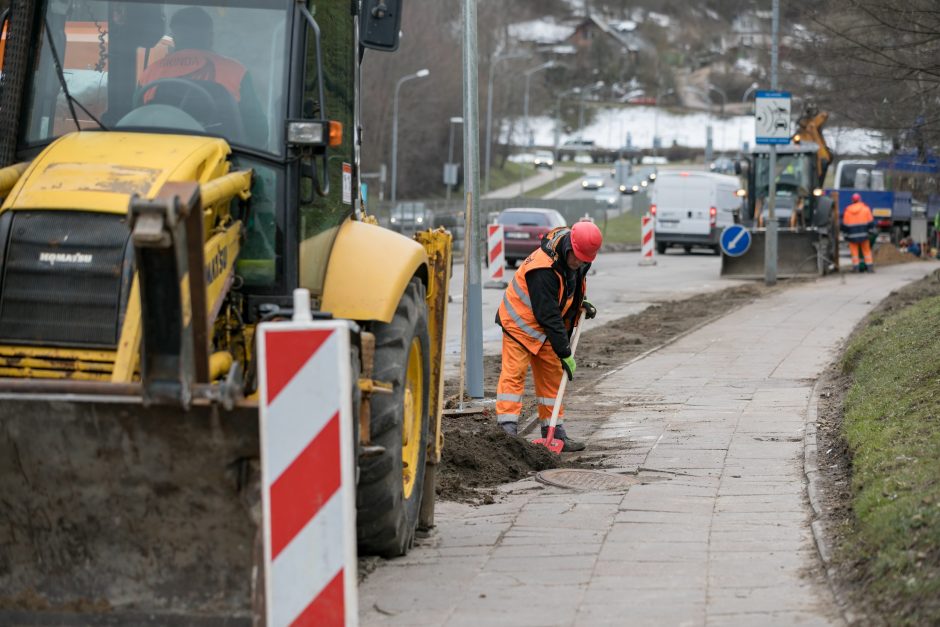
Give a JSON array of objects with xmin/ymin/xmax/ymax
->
[{"xmin": 360, "ymin": 263, "xmax": 937, "ymax": 626}]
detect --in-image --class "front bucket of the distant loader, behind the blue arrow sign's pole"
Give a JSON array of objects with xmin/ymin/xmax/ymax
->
[{"xmin": 721, "ymin": 229, "xmax": 828, "ymax": 279}]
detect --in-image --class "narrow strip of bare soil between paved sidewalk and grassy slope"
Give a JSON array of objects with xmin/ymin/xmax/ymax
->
[{"xmin": 816, "ymin": 262, "xmax": 940, "ymax": 625}]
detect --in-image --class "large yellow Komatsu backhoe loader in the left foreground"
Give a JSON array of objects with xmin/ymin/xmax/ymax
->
[{"xmin": 0, "ymin": 0, "xmax": 450, "ymax": 625}]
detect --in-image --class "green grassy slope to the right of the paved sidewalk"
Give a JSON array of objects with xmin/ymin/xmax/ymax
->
[{"xmin": 843, "ymin": 297, "xmax": 940, "ymax": 625}]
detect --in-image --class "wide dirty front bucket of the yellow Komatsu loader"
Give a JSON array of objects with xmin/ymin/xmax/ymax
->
[{"xmin": 0, "ymin": 381, "xmax": 263, "ymax": 626}]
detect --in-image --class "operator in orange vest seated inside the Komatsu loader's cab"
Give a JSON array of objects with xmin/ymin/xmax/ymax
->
[{"xmin": 140, "ymin": 7, "xmax": 268, "ymax": 147}]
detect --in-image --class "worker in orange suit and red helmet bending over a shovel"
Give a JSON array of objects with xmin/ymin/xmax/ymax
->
[{"xmin": 496, "ymin": 222, "xmax": 603, "ymax": 451}]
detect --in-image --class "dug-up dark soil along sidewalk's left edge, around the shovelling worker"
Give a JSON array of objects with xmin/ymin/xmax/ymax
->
[{"xmin": 438, "ymin": 282, "xmax": 776, "ymax": 504}]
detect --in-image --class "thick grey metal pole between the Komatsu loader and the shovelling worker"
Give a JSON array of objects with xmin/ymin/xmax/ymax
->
[{"xmin": 463, "ymin": 0, "xmax": 483, "ymax": 399}]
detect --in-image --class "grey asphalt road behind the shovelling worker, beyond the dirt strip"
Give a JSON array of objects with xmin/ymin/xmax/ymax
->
[{"xmin": 444, "ymin": 251, "xmax": 740, "ymax": 376}]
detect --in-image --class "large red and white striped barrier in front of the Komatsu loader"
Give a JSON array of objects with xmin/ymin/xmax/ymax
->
[{"xmin": 258, "ymin": 294, "xmax": 358, "ymax": 627}]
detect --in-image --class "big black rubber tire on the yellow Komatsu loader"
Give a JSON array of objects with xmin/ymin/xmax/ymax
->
[{"xmin": 356, "ymin": 279, "xmax": 431, "ymax": 557}]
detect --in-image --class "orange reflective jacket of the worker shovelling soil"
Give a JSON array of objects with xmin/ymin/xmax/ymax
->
[{"xmin": 496, "ymin": 226, "xmax": 586, "ymax": 355}]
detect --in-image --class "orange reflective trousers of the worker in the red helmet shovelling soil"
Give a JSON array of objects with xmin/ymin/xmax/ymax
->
[{"xmin": 496, "ymin": 333, "xmax": 565, "ymax": 424}]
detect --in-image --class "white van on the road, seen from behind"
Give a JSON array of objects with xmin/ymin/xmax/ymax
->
[{"xmin": 650, "ymin": 170, "xmax": 741, "ymax": 255}]
